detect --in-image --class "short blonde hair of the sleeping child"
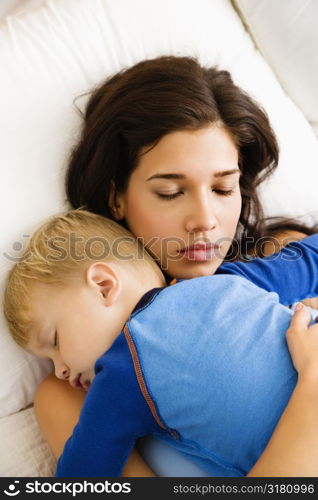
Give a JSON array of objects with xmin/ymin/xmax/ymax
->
[{"xmin": 3, "ymin": 209, "xmax": 162, "ymax": 347}]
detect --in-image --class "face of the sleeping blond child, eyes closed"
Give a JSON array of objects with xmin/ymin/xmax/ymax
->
[{"xmin": 26, "ymin": 283, "xmax": 117, "ymax": 390}]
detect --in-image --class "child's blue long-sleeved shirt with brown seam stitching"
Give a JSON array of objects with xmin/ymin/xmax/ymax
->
[{"xmin": 56, "ymin": 235, "xmax": 318, "ymax": 477}]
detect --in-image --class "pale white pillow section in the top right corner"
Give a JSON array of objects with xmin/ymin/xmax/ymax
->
[{"xmin": 234, "ymin": 0, "xmax": 318, "ymax": 135}]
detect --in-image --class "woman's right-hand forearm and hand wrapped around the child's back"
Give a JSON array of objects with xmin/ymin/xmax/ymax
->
[{"xmin": 248, "ymin": 307, "xmax": 318, "ymax": 477}]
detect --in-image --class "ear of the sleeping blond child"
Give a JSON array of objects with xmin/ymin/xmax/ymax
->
[{"xmin": 86, "ymin": 262, "xmax": 121, "ymax": 306}]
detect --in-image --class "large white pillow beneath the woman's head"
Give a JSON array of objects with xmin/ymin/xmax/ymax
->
[{"xmin": 0, "ymin": 0, "xmax": 318, "ymax": 415}]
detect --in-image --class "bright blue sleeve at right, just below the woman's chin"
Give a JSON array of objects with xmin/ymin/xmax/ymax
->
[{"xmin": 216, "ymin": 234, "xmax": 318, "ymax": 305}]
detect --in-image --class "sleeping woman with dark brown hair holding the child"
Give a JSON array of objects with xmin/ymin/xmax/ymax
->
[{"xmin": 35, "ymin": 56, "xmax": 318, "ymax": 476}]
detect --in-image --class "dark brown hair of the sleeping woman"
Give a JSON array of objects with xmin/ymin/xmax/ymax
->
[{"xmin": 66, "ymin": 56, "xmax": 278, "ymax": 254}]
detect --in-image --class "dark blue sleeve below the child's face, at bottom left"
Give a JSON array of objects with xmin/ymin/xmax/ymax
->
[{"xmin": 55, "ymin": 333, "xmax": 163, "ymax": 477}]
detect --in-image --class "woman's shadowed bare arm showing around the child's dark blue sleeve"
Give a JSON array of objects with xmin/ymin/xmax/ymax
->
[{"xmin": 34, "ymin": 373, "xmax": 155, "ymax": 477}]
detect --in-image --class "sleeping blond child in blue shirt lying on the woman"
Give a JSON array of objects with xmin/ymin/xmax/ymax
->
[{"xmin": 4, "ymin": 210, "xmax": 318, "ymax": 477}]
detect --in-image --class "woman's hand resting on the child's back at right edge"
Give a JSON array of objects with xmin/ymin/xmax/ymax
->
[{"xmin": 286, "ymin": 303, "xmax": 318, "ymax": 380}]
